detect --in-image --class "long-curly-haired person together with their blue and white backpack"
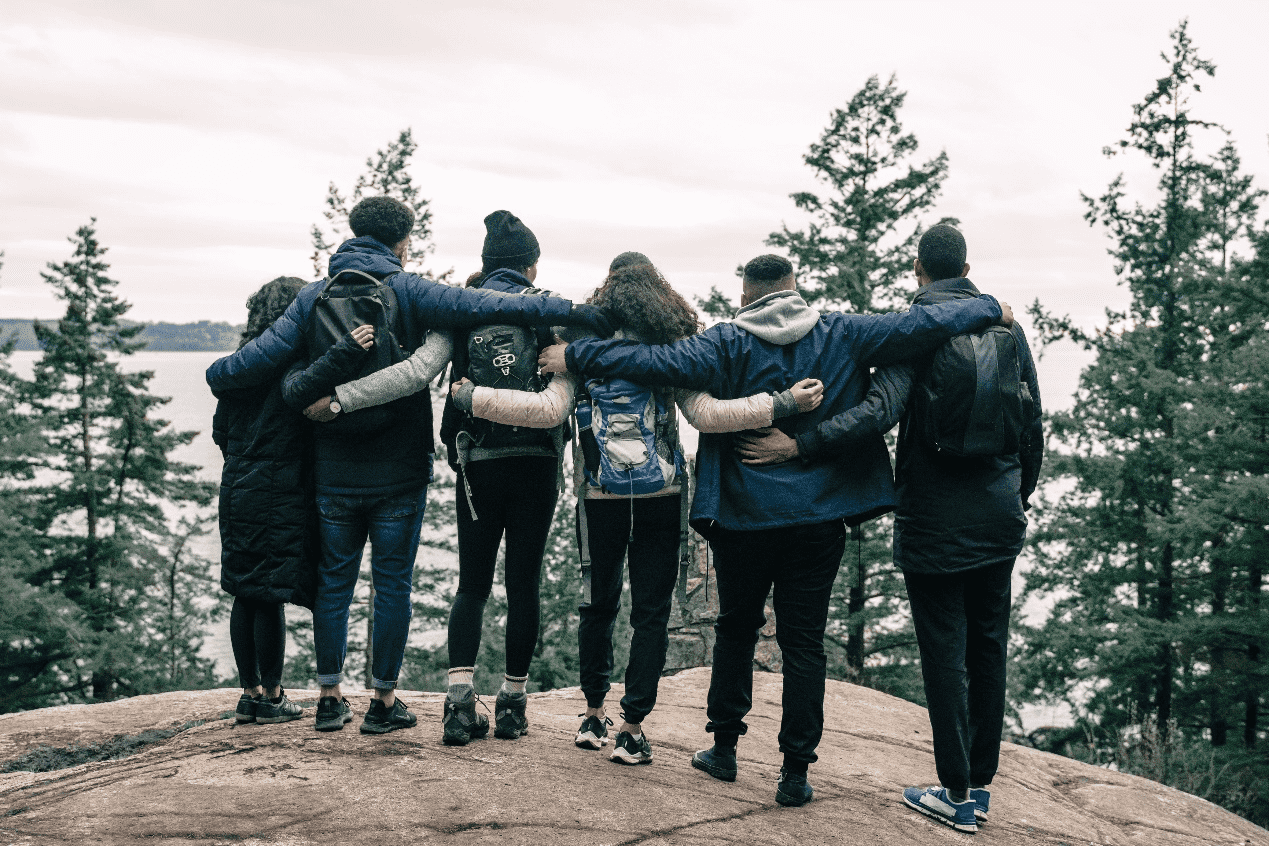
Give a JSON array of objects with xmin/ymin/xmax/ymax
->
[{"xmin": 453, "ymin": 252, "xmax": 821, "ymax": 764}]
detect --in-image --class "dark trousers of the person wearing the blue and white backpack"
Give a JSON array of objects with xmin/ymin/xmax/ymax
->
[{"xmin": 577, "ymin": 496, "xmax": 679, "ymax": 723}]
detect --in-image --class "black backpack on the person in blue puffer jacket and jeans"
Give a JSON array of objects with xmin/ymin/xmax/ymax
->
[{"xmin": 305, "ymin": 270, "xmax": 406, "ymax": 434}]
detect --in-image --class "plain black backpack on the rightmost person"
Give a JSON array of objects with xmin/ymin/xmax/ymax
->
[{"xmin": 914, "ymin": 326, "xmax": 1032, "ymax": 457}]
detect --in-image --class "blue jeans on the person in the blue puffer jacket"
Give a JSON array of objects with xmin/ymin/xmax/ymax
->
[{"xmin": 313, "ymin": 485, "xmax": 428, "ymax": 690}]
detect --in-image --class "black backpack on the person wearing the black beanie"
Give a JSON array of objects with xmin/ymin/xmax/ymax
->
[{"xmin": 462, "ymin": 288, "xmax": 555, "ymax": 449}]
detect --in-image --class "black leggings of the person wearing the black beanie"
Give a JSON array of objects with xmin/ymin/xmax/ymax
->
[{"xmin": 449, "ymin": 455, "xmax": 560, "ymax": 676}]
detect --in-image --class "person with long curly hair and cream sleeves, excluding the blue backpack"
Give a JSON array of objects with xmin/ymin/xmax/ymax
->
[{"xmin": 452, "ymin": 252, "xmax": 821, "ymax": 764}]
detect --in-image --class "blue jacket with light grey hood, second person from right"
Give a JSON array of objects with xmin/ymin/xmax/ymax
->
[{"xmin": 567, "ymin": 290, "xmax": 1000, "ymax": 538}]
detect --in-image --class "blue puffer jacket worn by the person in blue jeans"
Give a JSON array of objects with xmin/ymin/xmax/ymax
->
[{"xmin": 207, "ymin": 237, "xmax": 572, "ymax": 493}]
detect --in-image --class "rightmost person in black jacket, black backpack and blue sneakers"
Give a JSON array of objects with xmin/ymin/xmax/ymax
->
[{"xmin": 737, "ymin": 225, "xmax": 1044, "ymax": 832}]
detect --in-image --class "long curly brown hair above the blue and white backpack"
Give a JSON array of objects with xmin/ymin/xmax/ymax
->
[{"xmin": 586, "ymin": 264, "xmax": 704, "ymax": 344}]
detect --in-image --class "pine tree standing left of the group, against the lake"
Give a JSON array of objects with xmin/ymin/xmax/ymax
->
[{"xmin": 25, "ymin": 221, "xmax": 213, "ymax": 700}]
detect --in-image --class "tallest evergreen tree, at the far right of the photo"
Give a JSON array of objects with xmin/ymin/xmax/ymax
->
[{"xmin": 1019, "ymin": 22, "xmax": 1269, "ymax": 761}]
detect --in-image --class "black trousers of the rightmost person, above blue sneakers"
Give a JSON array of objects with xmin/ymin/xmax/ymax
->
[{"xmin": 904, "ymin": 561, "xmax": 1014, "ymax": 790}]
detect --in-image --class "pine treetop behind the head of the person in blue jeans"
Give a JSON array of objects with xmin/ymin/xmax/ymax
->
[{"xmin": 311, "ymin": 128, "xmax": 453, "ymax": 282}]
